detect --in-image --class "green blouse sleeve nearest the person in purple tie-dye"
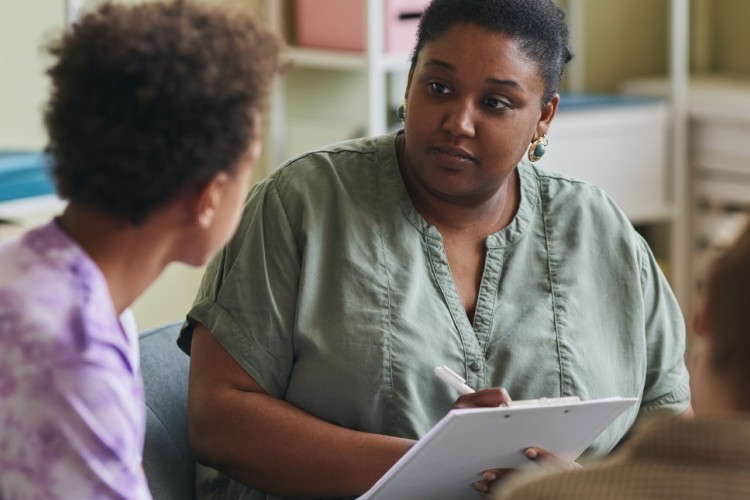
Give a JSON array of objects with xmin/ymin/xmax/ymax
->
[{"xmin": 180, "ymin": 178, "xmax": 301, "ymax": 398}]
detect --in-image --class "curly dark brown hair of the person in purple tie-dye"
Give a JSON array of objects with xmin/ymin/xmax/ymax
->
[{"xmin": 45, "ymin": 1, "xmax": 280, "ymax": 225}]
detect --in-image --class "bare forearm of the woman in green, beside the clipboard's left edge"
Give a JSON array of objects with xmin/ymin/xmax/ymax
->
[{"xmin": 190, "ymin": 389, "xmax": 413, "ymax": 497}]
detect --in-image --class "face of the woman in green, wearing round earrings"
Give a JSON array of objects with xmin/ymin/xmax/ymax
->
[{"xmin": 402, "ymin": 23, "xmax": 558, "ymax": 204}]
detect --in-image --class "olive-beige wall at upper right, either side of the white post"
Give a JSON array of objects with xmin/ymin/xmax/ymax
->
[{"xmin": 560, "ymin": 0, "xmax": 750, "ymax": 92}]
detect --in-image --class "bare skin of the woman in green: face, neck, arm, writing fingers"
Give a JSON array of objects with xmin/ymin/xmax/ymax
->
[{"xmin": 188, "ymin": 25, "xmax": 558, "ymax": 497}]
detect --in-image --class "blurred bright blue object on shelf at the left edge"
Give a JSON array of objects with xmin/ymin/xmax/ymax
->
[{"xmin": 0, "ymin": 150, "xmax": 55, "ymax": 201}]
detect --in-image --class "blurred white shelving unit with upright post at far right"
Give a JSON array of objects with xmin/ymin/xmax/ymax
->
[{"xmin": 625, "ymin": 0, "xmax": 750, "ymax": 324}]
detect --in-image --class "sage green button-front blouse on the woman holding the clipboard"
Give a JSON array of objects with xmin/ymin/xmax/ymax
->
[{"xmin": 181, "ymin": 134, "xmax": 689, "ymax": 498}]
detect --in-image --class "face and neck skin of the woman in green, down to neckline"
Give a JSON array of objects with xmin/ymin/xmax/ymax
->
[{"xmin": 397, "ymin": 24, "xmax": 559, "ymax": 319}]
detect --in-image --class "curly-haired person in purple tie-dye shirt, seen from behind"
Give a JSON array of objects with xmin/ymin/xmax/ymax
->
[{"xmin": 0, "ymin": 1, "xmax": 279, "ymax": 499}]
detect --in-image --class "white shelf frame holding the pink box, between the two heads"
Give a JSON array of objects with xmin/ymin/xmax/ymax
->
[{"xmin": 266, "ymin": 0, "xmax": 410, "ymax": 167}]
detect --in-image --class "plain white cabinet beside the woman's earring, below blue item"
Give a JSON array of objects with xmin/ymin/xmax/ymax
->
[{"xmin": 538, "ymin": 96, "xmax": 675, "ymax": 224}]
